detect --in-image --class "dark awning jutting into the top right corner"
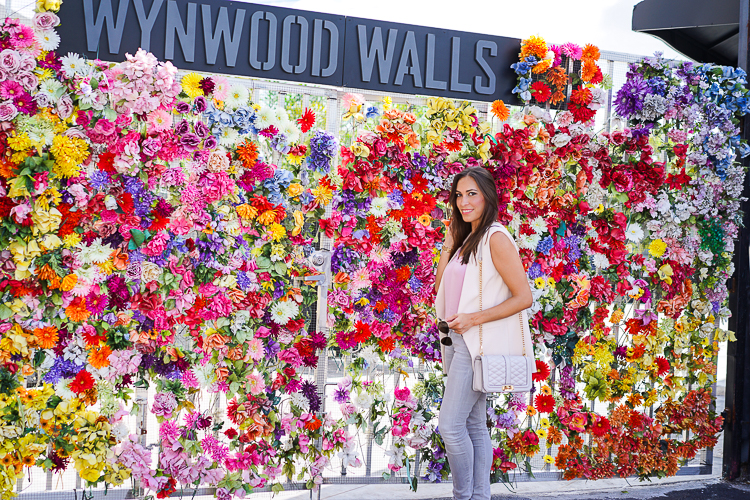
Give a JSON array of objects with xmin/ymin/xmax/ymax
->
[{"xmin": 633, "ymin": 0, "xmax": 740, "ymax": 66}]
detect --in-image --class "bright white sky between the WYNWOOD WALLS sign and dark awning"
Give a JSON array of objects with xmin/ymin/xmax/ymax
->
[{"xmin": 258, "ymin": 0, "xmax": 685, "ymax": 59}]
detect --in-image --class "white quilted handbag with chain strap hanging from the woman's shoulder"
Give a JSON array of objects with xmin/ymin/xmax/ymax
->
[{"xmin": 473, "ymin": 232, "xmax": 535, "ymax": 392}]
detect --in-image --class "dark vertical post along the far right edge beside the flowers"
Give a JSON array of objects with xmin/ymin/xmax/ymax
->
[{"xmin": 723, "ymin": 0, "xmax": 750, "ymax": 480}]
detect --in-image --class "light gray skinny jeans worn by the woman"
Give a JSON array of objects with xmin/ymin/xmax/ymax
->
[{"xmin": 438, "ymin": 330, "xmax": 492, "ymax": 500}]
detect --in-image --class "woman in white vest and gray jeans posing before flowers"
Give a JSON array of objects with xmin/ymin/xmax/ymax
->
[{"xmin": 435, "ymin": 167, "xmax": 532, "ymax": 500}]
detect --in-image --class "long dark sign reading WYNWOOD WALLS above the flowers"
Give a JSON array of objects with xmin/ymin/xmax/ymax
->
[{"xmin": 58, "ymin": 0, "xmax": 520, "ymax": 102}]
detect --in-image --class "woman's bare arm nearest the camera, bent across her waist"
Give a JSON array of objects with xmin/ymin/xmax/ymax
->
[{"xmin": 447, "ymin": 232, "xmax": 533, "ymax": 334}]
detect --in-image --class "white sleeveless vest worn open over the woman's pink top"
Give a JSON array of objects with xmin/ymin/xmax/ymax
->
[{"xmin": 435, "ymin": 222, "xmax": 534, "ymax": 374}]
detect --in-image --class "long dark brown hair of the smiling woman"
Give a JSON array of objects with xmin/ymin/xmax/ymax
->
[{"xmin": 448, "ymin": 167, "xmax": 498, "ymax": 264}]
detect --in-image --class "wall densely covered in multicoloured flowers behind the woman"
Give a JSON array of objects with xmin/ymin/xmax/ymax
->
[{"xmin": 0, "ymin": 3, "xmax": 747, "ymax": 498}]
